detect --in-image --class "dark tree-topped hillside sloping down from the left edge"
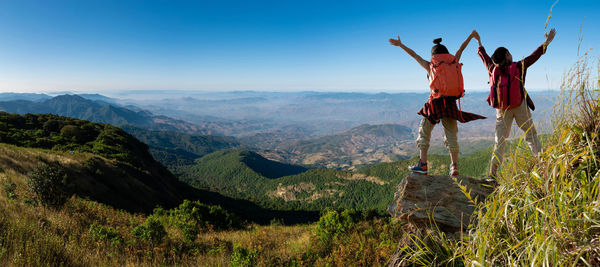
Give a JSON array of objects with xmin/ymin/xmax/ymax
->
[{"xmin": 0, "ymin": 112, "xmax": 189, "ymax": 211}]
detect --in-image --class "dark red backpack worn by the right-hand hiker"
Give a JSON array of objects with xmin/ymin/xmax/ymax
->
[{"xmin": 489, "ymin": 62, "xmax": 523, "ymax": 110}]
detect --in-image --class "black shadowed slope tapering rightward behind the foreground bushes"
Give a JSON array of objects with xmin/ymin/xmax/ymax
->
[{"xmin": 69, "ymin": 159, "xmax": 320, "ymax": 224}]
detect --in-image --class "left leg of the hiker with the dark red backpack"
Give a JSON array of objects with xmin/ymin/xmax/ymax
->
[{"xmin": 489, "ymin": 109, "xmax": 513, "ymax": 177}]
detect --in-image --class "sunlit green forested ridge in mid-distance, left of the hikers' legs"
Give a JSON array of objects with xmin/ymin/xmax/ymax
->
[{"xmin": 175, "ymin": 150, "xmax": 490, "ymax": 214}]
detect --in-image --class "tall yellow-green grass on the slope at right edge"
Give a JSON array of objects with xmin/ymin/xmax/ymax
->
[{"xmin": 396, "ymin": 50, "xmax": 600, "ymax": 266}]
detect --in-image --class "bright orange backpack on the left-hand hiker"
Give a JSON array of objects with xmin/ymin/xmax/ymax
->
[{"xmin": 428, "ymin": 54, "xmax": 465, "ymax": 99}]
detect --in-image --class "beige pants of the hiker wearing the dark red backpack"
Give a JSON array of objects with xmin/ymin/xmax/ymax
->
[{"xmin": 490, "ymin": 100, "xmax": 542, "ymax": 176}]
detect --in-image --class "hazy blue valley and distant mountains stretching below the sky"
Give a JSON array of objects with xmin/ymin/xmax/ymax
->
[{"xmin": 0, "ymin": 91, "xmax": 557, "ymax": 169}]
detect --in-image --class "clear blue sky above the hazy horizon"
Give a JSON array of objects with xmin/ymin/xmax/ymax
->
[{"xmin": 0, "ymin": 0, "xmax": 600, "ymax": 93}]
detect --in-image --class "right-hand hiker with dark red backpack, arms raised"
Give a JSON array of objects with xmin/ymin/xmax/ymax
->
[{"xmin": 473, "ymin": 29, "xmax": 556, "ymax": 183}]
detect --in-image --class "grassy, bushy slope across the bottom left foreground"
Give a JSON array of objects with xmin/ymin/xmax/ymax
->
[{"xmin": 0, "ymin": 186, "xmax": 402, "ymax": 266}]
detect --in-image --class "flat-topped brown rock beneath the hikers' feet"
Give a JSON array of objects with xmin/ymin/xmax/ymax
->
[{"xmin": 388, "ymin": 174, "xmax": 493, "ymax": 232}]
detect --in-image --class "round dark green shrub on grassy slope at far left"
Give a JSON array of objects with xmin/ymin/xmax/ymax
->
[{"xmin": 27, "ymin": 165, "xmax": 71, "ymax": 208}]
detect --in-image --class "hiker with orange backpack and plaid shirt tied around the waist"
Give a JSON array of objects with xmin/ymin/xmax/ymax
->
[{"xmin": 389, "ymin": 31, "xmax": 485, "ymax": 176}]
